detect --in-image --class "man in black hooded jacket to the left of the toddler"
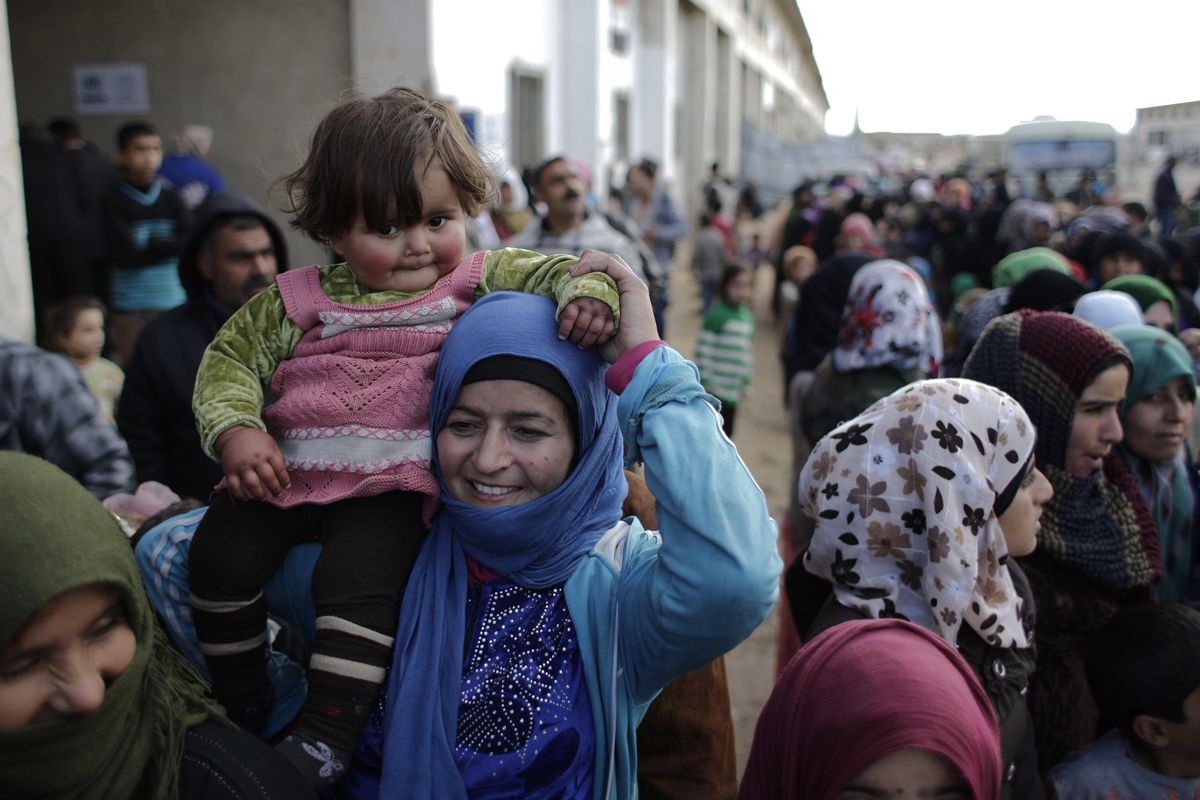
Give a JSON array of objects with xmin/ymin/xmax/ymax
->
[{"xmin": 116, "ymin": 192, "xmax": 287, "ymax": 500}]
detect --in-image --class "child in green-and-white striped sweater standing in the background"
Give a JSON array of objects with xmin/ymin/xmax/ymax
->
[{"xmin": 696, "ymin": 264, "xmax": 754, "ymax": 438}]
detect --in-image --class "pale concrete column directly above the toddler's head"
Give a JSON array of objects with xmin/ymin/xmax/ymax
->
[{"xmin": 349, "ymin": 0, "xmax": 434, "ymax": 95}]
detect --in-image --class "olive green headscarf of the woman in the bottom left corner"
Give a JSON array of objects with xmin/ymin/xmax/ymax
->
[{"xmin": 0, "ymin": 452, "xmax": 221, "ymax": 800}]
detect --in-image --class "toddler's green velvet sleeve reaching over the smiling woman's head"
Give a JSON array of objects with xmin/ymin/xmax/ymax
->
[{"xmin": 475, "ymin": 247, "xmax": 620, "ymax": 325}]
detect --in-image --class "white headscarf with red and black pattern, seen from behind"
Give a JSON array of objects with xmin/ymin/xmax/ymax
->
[{"xmin": 833, "ymin": 259, "xmax": 942, "ymax": 375}]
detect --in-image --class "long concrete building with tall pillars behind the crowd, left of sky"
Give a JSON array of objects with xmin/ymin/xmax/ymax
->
[{"xmin": 0, "ymin": 0, "xmax": 828, "ymax": 335}]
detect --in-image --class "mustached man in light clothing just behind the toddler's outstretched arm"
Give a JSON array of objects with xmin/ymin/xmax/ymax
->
[{"xmin": 506, "ymin": 156, "xmax": 659, "ymax": 287}]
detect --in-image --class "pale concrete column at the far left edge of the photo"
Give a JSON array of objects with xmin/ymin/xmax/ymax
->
[{"xmin": 0, "ymin": 0, "xmax": 34, "ymax": 342}]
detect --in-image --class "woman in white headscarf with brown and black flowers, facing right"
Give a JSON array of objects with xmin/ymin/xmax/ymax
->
[{"xmin": 794, "ymin": 379, "xmax": 1051, "ymax": 798}]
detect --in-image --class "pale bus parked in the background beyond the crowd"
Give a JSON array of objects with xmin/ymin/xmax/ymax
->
[{"xmin": 1004, "ymin": 116, "xmax": 1121, "ymax": 198}]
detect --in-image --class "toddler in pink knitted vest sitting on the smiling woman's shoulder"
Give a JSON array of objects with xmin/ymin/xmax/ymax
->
[{"xmin": 190, "ymin": 89, "xmax": 618, "ymax": 787}]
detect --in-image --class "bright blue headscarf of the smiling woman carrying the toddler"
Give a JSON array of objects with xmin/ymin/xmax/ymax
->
[{"xmin": 379, "ymin": 293, "xmax": 626, "ymax": 798}]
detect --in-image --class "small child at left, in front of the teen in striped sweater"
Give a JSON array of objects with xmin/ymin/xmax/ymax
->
[{"xmin": 44, "ymin": 295, "xmax": 125, "ymax": 422}]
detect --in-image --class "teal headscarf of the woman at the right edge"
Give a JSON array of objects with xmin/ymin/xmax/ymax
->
[{"xmin": 1110, "ymin": 326, "xmax": 1196, "ymax": 602}]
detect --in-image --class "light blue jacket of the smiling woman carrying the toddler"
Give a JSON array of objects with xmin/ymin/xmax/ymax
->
[{"xmin": 138, "ymin": 347, "xmax": 782, "ymax": 800}]
